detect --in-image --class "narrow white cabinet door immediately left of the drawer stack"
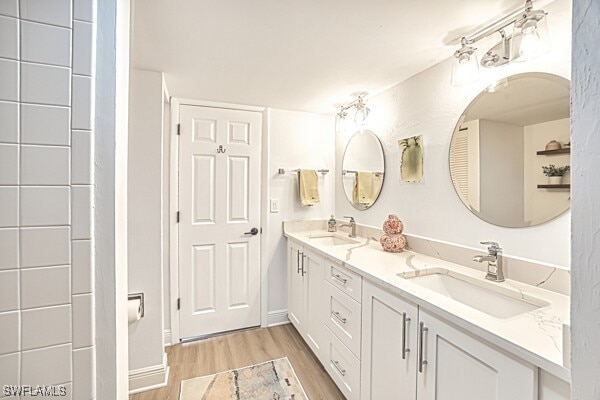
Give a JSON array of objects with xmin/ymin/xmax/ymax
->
[{"xmin": 304, "ymin": 251, "xmax": 327, "ymax": 362}]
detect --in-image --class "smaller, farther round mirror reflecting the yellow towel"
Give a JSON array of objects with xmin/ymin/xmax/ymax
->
[{"xmin": 342, "ymin": 130, "xmax": 385, "ymax": 210}]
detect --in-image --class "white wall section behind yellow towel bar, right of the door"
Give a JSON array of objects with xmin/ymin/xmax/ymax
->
[{"xmin": 263, "ymin": 109, "xmax": 337, "ymax": 312}]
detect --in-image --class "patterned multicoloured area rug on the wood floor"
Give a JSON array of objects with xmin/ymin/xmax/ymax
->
[{"xmin": 179, "ymin": 357, "xmax": 308, "ymax": 400}]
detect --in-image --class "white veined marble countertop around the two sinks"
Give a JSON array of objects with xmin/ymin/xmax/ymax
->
[{"xmin": 284, "ymin": 224, "xmax": 571, "ymax": 382}]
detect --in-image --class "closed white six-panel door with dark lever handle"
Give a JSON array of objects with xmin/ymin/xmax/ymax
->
[{"xmin": 179, "ymin": 105, "xmax": 262, "ymax": 338}]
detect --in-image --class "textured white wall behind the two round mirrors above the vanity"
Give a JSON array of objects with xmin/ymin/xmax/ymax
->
[{"xmin": 335, "ymin": 0, "xmax": 571, "ymax": 268}]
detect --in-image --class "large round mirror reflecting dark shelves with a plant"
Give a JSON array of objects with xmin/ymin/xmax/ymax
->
[{"xmin": 449, "ymin": 72, "xmax": 571, "ymax": 228}]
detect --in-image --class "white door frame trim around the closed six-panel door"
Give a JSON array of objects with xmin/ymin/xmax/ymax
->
[{"xmin": 168, "ymin": 97, "xmax": 269, "ymax": 344}]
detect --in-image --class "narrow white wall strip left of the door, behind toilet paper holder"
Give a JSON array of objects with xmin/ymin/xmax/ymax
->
[{"xmin": 127, "ymin": 69, "xmax": 164, "ymax": 380}]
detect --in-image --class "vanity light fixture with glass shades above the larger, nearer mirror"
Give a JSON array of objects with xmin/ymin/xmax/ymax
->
[{"xmin": 452, "ymin": 0, "xmax": 550, "ymax": 86}]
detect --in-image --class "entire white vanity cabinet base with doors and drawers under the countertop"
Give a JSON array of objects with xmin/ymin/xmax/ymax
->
[{"xmin": 288, "ymin": 240, "xmax": 570, "ymax": 400}]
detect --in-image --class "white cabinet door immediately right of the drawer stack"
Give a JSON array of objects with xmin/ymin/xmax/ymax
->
[{"xmin": 361, "ymin": 282, "xmax": 418, "ymax": 400}]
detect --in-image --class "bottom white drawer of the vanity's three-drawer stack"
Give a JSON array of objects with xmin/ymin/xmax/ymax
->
[{"xmin": 325, "ymin": 329, "xmax": 360, "ymax": 400}]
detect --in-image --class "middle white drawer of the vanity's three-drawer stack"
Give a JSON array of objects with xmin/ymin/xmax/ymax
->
[{"xmin": 325, "ymin": 284, "xmax": 362, "ymax": 359}]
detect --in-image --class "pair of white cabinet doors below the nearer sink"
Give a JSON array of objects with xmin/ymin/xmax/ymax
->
[{"xmin": 361, "ymin": 282, "xmax": 537, "ymax": 400}]
